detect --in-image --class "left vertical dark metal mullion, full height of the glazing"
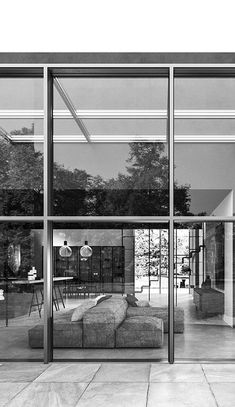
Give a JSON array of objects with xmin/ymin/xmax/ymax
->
[{"xmin": 43, "ymin": 67, "xmax": 53, "ymax": 363}]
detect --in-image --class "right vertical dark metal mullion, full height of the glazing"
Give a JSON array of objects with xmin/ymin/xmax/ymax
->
[{"xmin": 168, "ymin": 66, "xmax": 174, "ymax": 363}]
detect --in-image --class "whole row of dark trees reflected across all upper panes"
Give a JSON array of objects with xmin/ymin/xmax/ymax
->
[{"xmin": 0, "ymin": 130, "xmax": 189, "ymax": 216}]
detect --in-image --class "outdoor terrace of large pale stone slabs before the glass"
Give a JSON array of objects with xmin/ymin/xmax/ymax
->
[{"xmin": 0, "ymin": 362, "xmax": 235, "ymax": 407}]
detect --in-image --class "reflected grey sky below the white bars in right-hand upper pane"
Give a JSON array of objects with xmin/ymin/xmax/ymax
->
[{"xmin": 175, "ymin": 143, "xmax": 235, "ymax": 214}]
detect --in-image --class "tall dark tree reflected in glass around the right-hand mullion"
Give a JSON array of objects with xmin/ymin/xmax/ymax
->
[{"xmin": 92, "ymin": 143, "xmax": 190, "ymax": 216}]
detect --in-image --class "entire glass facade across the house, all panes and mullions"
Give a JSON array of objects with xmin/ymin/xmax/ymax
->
[{"xmin": 0, "ymin": 65, "xmax": 235, "ymax": 363}]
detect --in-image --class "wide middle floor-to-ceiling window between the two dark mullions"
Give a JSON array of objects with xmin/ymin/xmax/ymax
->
[{"xmin": 48, "ymin": 69, "xmax": 172, "ymax": 359}]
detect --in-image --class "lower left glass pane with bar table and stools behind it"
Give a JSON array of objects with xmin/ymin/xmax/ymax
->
[{"xmin": 0, "ymin": 223, "xmax": 44, "ymax": 359}]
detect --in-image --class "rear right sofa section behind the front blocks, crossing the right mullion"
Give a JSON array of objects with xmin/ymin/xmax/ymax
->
[{"xmin": 127, "ymin": 306, "xmax": 184, "ymax": 333}]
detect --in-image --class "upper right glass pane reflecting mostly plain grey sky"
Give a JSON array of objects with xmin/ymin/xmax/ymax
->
[{"xmin": 175, "ymin": 78, "xmax": 235, "ymax": 216}]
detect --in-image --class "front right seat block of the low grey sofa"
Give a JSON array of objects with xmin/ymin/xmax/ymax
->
[{"xmin": 116, "ymin": 316, "xmax": 164, "ymax": 348}]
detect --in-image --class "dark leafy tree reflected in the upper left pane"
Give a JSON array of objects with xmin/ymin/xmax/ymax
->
[{"xmin": 0, "ymin": 127, "xmax": 43, "ymax": 215}]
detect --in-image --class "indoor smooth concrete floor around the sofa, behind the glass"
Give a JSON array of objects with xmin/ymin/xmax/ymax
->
[{"xmin": 0, "ymin": 289, "xmax": 235, "ymax": 360}]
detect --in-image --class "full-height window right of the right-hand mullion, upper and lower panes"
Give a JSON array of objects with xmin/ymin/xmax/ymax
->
[{"xmin": 174, "ymin": 69, "xmax": 235, "ymax": 360}]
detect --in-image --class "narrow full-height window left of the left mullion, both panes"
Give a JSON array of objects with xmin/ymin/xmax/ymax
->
[{"xmin": 0, "ymin": 70, "xmax": 44, "ymax": 360}]
